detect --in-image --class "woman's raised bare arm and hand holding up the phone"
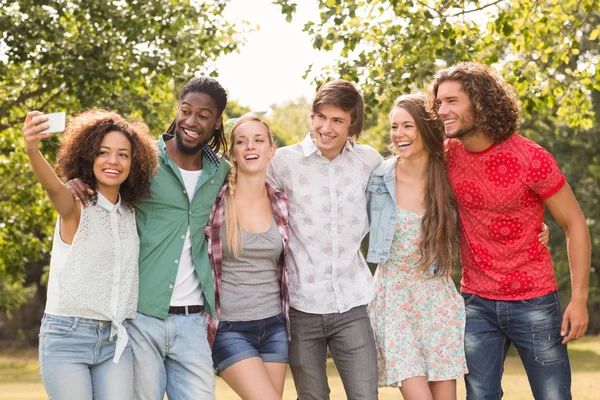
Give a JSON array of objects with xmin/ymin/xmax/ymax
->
[{"xmin": 22, "ymin": 111, "xmax": 79, "ymax": 220}]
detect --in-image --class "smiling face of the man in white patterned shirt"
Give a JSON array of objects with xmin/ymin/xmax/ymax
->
[{"xmin": 312, "ymin": 106, "xmax": 352, "ymax": 160}]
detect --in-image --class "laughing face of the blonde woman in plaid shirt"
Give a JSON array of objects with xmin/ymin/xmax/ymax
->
[{"xmin": 232, "ymin": 120, "xmax": 275, "ymax": 175}]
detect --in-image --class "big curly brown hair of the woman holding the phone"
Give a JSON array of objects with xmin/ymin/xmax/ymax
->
[{"xmin": 55, "ymin": 108, "xmax": 158, "ymax": 206}]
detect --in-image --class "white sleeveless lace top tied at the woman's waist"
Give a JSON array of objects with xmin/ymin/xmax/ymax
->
[{"xmin": 46, "ymin": 193, "xmax": 140, "ymax": 362}]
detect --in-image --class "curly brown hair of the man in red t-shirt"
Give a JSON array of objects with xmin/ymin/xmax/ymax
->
[{"xmin": 427, "ymin": 62, "xmax": 520, "ymax": 143}]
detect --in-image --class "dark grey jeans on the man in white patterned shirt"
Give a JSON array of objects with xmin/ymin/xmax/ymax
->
[{"xmin": 289, "ymin": 305, "xmax": 377, "ymax": 400}]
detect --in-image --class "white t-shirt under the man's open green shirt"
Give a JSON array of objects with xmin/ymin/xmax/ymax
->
[{"xmin": 170, "ymin": 168, "xmax": 204, "ymax": 306}]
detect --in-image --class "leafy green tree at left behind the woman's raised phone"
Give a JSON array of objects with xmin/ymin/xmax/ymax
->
[{"xmin": 0, "ymin": 0, "xmax": 245, "ymax": 311}]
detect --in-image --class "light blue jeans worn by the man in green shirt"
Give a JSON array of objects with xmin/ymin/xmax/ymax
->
[{"xmin": 129, "ymin": 312, "xmax": 215, "ymax": 400}]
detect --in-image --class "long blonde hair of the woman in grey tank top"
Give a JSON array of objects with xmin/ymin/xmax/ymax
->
[{"xmin": 225, "ymin": 113, "xmax": 275, "ymax": 257}]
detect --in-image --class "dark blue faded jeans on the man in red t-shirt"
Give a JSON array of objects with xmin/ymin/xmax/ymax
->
[{"xmin": 462, "ymin": 292, "xmax": 571, "ymax": 400}]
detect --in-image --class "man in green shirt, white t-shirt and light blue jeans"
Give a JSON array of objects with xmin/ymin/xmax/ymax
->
[{"xmin": 72, "ymin": 77, "xmax": 229, "ymax": 400}]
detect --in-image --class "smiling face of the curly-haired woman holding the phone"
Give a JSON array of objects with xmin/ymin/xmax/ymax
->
[{"xmin": 93, "ymin": 131, "xmax": 132, "ymax": 193}]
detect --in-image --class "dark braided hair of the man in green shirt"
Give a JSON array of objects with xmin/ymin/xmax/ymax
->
[{"xmin": 167, "ymin": 76, "xmax": 227, "ymax": 153}]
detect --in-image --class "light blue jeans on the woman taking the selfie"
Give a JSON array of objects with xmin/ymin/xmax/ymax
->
[{"xmin": 39, "ymin": 314, "xmax": 133, "ymax": 400}]
